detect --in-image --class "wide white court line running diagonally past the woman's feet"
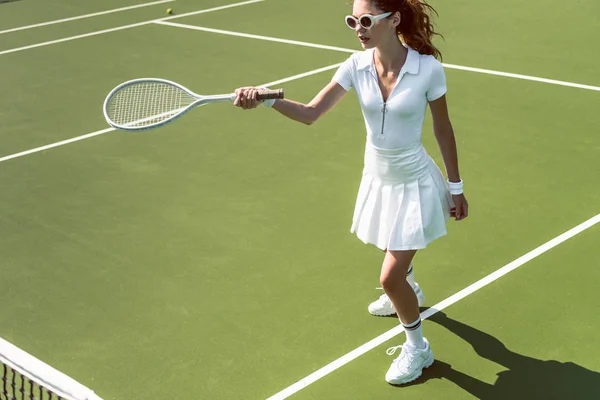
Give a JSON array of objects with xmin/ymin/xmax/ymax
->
[{"xmin": 267, "ymin": 214, "xmax": 600, "ymax": 400}]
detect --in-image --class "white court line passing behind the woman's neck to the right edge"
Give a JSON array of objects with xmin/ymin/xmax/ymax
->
[{"xmin": 157, "ymin": 20, "xmax": 600, "ymax": 92}]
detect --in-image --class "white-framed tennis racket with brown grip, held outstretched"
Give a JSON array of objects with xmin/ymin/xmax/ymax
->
[{"xmin": 104, "ymin": 78, "xmax": 283, "ymax": 131}]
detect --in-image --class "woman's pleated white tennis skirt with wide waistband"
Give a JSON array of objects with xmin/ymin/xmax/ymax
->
[{"xmin": 350, "ymin": 142, "xmax": 454, "ymax": 250}]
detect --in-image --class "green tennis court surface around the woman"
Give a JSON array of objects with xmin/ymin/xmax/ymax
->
[{"xmin": 0, "ymin": 0, "xmax": 600, "ymax": 400}]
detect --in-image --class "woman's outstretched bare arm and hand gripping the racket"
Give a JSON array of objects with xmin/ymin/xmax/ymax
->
[{"xmin": 233, "ymin": 81, "xmax": 347, "ymax": 125}]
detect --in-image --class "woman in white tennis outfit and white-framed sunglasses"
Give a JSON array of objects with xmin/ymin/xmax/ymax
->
[{"xmin": 234, "ymin": 0, "xmax": 468, "ymax": 384}]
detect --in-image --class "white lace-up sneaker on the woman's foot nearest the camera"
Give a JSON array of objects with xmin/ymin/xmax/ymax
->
[{"xmin": 385, "ymin": 339, "xmax": 433, "ymax": 385}]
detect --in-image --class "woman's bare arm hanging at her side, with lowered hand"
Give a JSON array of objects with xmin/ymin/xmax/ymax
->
[{"xmin": 429, "ymin": 95, "xmax": 469, "ymax": 221}]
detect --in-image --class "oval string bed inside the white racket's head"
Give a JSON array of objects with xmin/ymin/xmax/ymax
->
[{"xmin": 107, "ymin": 82, "xmax": 196, "ymax": 127}]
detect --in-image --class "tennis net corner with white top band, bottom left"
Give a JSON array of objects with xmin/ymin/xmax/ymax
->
[{"xmin": 0, "ymin": 338, "xmax": 102, "ymax": 400}]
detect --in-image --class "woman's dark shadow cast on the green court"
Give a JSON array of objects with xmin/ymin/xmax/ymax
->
[{"xmin": 412, "ymin": 312, "xmax": 600, "ymax": 400}]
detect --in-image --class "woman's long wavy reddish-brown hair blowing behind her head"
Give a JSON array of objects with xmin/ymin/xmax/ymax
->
[{"xmin": 370, "ymin": 0, "xmax": 443, "ymax": 60}]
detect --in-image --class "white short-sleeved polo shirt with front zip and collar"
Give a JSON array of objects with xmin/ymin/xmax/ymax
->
[{"xmin": 333, "ymin": 47, "xmax": 446, "ymax": 149}]
